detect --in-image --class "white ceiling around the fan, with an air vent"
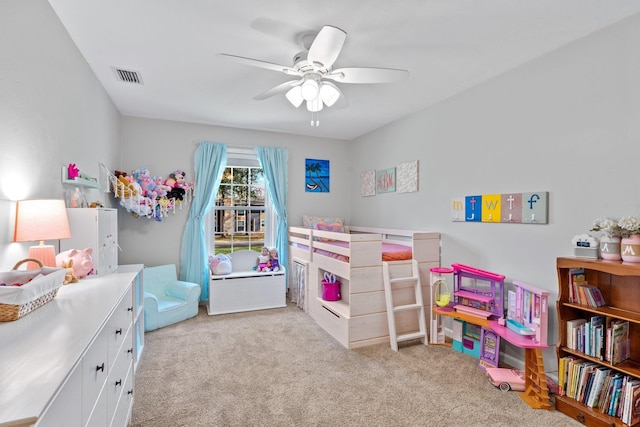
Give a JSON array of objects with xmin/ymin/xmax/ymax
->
[{"xmin": 49, "ymin": 0, "xmax": 640, "ymax": 139}]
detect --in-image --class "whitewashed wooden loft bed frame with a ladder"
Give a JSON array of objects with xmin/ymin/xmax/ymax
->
[{"xmin": 289, "ymin": 226, "xmax": 440, "ymax": 349}]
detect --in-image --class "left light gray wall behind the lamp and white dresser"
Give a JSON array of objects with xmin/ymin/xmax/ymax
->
[{"xmin": 0, "ymin": 0, "xmax": 120, "ymax": 270}]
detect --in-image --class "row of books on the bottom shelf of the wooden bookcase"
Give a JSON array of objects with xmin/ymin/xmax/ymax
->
[{"xmin": 558, "ymin": 356, "xmax": 640, "ymax": 426}]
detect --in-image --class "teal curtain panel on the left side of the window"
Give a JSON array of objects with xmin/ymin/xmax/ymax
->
[{"xmin": 180, "ymin": 142, "xmax": 227, "ymax": 301}]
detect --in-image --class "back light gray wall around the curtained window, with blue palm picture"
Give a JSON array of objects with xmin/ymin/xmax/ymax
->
[{"xmin": 114, "ymin": 117, "xmax": 350, "ymax": 265}]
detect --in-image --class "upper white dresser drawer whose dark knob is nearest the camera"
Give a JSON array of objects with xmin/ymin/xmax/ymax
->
[{"xmin": 82, "ymin": 329, "xmax": 109, "ymax": 423}]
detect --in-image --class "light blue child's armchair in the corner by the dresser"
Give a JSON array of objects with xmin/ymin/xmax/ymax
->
[{"xmin": 143, "ymin": 264, "xmax": 200, "ymax": 332}]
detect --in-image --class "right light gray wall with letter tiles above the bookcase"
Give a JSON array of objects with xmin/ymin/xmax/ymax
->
[{"xmin": 351, "ymin": 17, "xmax": 640, "ymax": 372}]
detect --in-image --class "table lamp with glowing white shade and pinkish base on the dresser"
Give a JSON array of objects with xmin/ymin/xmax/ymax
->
[{"xmin": 13, "ymin": 200, "xmax": 71, "ymax": 270}]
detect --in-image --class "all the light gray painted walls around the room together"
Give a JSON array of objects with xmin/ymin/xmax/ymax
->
[{"xmin": 0, "ymin": 0, "xmax": 640, "ymax": 370}]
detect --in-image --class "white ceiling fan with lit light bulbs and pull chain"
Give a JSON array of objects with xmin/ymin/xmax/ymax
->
[{"xmin": 218, "ymin": 25, "xmax": 409, "ymax": 125}]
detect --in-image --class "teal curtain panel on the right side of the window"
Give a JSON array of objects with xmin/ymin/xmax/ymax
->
[{"xmin": 254, "ymin": 147, "xmax": 289, "ymax": 286}]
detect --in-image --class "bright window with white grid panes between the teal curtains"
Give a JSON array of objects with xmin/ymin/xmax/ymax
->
[{"xmin": 205, "ymin": 150, "xmax": 274, "ymax": 255}]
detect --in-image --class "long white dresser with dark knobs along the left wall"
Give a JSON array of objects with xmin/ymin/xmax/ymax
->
[{"xmin": 0, "ymin": 265, "xmax": 143, "ymax": 427}]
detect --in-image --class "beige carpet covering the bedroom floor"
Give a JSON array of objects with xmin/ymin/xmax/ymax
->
[{"xmin": 132, "ymin": 305, "xmax": 581, "ymax": 427}]
